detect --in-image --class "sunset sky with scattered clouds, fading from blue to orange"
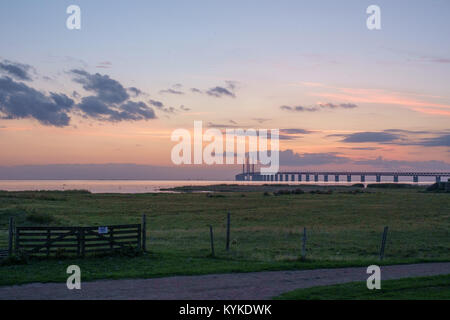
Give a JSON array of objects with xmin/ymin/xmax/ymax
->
[{"xmin": 0, "ymin": 0, "xmax": 450, "ymax": 179}]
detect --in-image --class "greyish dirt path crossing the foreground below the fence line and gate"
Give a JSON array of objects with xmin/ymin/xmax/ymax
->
[{"xmin": 0, "ymin": 263, "xmax": 450, "ymax": 300}]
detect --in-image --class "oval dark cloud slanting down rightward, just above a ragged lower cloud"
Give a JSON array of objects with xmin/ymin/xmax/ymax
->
[{"xmin": 71, "ymin": 69, "xmax": 130, "ymax": 103}]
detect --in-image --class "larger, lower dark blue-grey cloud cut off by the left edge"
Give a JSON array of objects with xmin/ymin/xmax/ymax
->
[{"xmin": 0, "ymin": 77, "xmax": 74, "ymax": 127}]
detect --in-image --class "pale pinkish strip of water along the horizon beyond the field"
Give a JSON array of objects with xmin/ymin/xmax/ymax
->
[{"xmin": 0, "ymin": 179, "xmax": 434, "ymax": 193}]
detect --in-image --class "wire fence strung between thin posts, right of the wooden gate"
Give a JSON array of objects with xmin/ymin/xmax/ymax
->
[{"xmin": 0, "ymin": 215, "xmax": 450, "ymax": 262}]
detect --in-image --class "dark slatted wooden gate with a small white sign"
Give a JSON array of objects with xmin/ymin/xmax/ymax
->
[{"xmin": 14, "ymin": 224, "xmax": 146, "ymax": 257}]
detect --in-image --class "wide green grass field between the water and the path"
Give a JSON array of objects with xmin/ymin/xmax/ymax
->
[{"xmin": 0, "ymin": 187, "xmax": 450, "ymax": 285}]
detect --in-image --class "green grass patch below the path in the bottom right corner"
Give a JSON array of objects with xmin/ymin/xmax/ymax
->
[{"xmin": 275, "ymin": 274, "xmax": 450, "ymax": 300}]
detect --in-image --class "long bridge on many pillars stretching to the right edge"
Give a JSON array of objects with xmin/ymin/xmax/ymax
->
[{"xmin": 235, "ymin": 170, "xmax": 450, "ymax": 182}]
